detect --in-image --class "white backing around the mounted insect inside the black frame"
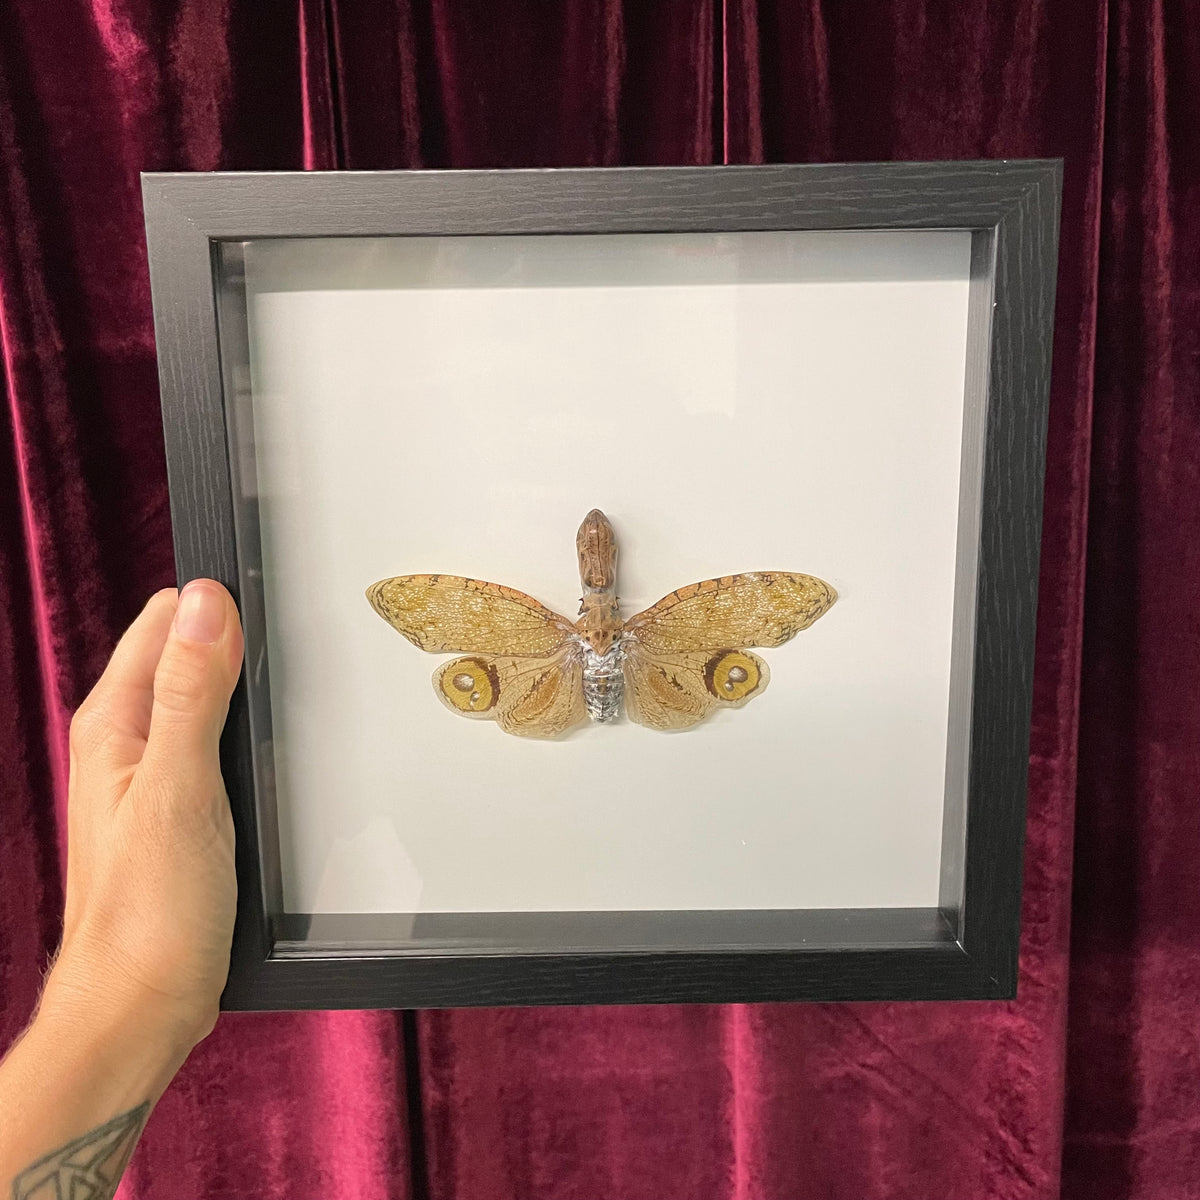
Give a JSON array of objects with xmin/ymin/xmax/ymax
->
[{"xmin": 220, "ymin": 229, "xmax": 980, "ymax": 952}]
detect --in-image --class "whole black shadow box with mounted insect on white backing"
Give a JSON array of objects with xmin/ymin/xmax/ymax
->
[{"xmin": 143, "ymin": 161, "xmax": 1061, "ymax": 1008}]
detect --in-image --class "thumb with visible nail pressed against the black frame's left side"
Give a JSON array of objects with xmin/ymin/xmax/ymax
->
[{"xmin": 143, "ymin": 580, "xmax": 242, "ymax": 768}]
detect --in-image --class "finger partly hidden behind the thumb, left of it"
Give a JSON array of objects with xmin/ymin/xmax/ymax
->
[{"xmin": 71, "ymin": 588, "xmax": 179, "ymax": 769}]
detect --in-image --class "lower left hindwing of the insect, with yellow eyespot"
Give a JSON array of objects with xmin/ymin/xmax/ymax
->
[{"xmin": 433, "ymin": 644, "xmax": 587, "ymax": 738}]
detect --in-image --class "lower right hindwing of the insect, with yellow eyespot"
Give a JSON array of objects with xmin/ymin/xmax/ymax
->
[{"xmin": 624, "ymin": 641, "xmax": 770, "ymax": 730}]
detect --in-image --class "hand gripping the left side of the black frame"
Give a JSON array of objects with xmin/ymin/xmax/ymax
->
[{"xmin": 43, "ymin": 580, "xmax": 242, "ymax": 1055}]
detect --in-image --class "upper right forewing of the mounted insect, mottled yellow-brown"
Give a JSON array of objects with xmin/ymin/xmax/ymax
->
[{"xmin": 625, "ymin": 571, "xmax": 838, "ymax": 654}]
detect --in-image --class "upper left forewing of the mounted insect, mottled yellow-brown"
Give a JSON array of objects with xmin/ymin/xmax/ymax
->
[{"xmin": 367, "ymin": 575, "xmax": 575, "ymax": 658}]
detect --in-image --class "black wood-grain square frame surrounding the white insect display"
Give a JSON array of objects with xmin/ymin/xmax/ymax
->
[{"xmin": 142, "ymin": 160, "xmax": 1062, "ymax": 1009}]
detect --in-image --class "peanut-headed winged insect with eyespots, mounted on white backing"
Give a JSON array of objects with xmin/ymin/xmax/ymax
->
[{"xmin": 367, "ymin": 509, "xmax": 838, "ymax": 738}]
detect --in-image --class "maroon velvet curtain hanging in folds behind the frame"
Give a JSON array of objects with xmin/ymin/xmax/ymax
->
[{"xmin": 0, "ymin": 0, "xmax": 1200, "ymax": 1200}]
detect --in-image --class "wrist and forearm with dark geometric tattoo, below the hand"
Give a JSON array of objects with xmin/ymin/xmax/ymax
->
[{"xmin": 0, "ymin": 967, "xmax": 191, "ymax": 1200}]
